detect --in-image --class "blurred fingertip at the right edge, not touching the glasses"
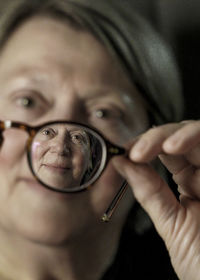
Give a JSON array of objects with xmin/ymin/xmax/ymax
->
[{"xmin": 163, "ymin": 121, "xmax": 200, "ymax": 154}]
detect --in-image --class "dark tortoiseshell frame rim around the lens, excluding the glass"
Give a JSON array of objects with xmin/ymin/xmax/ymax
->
[{"xmin": 0, "ymin": 119, "xmax": 126, "ymax": 194}]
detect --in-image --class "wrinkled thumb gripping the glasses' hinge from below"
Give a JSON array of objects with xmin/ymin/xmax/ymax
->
[{"xmin": 113, "ymin": 157, "xmax": 180, "ymax": 238}]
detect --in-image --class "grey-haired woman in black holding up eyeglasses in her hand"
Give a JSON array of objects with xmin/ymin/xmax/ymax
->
[{"xmin": 0, "ymin": 0, "xmax": 200, "ymax": 280}]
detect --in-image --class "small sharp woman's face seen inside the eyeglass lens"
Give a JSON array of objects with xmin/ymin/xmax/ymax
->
[{"xmin": 32, "ymin": 124, "xmax": 91, "ymax": 189}]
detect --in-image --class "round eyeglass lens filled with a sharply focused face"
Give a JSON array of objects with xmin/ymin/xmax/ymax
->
[{"xmin": 30, "ymin": 123, "xmax": 106, "ymax": 192}]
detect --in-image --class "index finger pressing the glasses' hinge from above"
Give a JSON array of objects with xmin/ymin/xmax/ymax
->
[{"xmin": 129, "ymin": 123, "xmax": 183, "ymax": 163}]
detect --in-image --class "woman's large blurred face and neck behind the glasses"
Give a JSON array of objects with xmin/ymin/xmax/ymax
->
[{"xmin": 0, "ymin": 17, "xmax": 148, "ymax": 280}]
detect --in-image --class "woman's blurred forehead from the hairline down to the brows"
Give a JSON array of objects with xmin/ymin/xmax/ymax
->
[{"xmin": 0, "ymin": 14, "xmax": 142, "ymax": 107}]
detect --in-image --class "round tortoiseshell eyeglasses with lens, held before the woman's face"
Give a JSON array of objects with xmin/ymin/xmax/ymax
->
[{"xmin": 0, "ymin": 120, "xmax": 127, "ymax": 221}]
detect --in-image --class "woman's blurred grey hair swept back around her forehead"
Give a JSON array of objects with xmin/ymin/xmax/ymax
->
[{"xmin": 0, "ymin": 0, "xmax": 183, "ymax": 124}]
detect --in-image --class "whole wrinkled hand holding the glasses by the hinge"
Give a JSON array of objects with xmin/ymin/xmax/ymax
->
[{"xmin": 114, "ymin": 121, "xmax": 200, "ymax": 280}]
